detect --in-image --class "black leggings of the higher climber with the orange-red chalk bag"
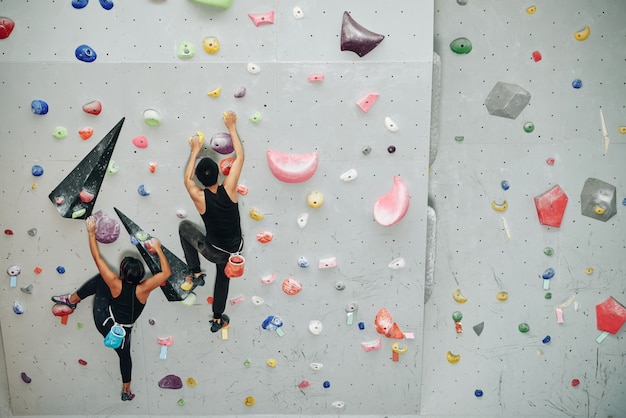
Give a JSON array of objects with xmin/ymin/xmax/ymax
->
[{"xmin": 178, "ymin": 221, "xmax": 230, "ymax": 319}]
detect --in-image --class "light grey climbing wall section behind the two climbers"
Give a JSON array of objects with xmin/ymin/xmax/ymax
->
[{"xmin": 0, "ymin": 0, "xmax": 433, "ymax": 416}]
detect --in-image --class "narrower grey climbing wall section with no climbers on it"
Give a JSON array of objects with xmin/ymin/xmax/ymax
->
[{"xmin": 422, "ymin": 0, "xmax": 626, "ymax": 418}]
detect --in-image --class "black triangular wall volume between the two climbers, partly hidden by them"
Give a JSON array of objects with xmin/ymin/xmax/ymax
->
[{"xmin": 113, "ymin": 208, "xmax": 196, "ymax": 302}]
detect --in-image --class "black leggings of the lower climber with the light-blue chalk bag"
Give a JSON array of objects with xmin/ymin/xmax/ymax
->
[{"xmin": 76, "ymin": 274, "xmax": 133, "ymax": 383}]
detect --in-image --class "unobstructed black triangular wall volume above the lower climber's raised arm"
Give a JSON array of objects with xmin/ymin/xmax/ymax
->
[{"xmin": 48, "ymin": 118, "xmax": 125, "ymax": 219}]
